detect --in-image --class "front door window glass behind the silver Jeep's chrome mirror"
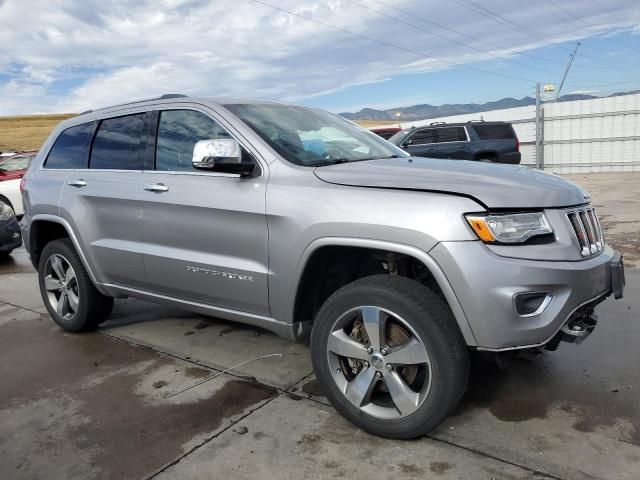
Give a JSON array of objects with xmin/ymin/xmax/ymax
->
[{"xmin": 156, "ymin": 110, "xmax": 231, "ymax": 171}]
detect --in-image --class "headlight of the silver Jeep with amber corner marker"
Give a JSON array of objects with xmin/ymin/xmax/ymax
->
[{"xmin": 466, "ymin": 212, "xmax": 553, "ymax": 243}]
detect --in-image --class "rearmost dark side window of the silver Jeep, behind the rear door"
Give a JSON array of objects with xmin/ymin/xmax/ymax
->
[{"xmin": 44, "ymin": 123, "xmax": 93, "ymax": 168}]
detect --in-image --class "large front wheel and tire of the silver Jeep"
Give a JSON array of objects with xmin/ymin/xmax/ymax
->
[{"xmin": 311, "ymin": 275, "xmax": 469, "ymax": 439}]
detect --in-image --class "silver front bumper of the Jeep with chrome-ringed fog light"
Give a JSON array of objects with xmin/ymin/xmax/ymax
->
[{"xmin": 429, "ymin": 242, "xmax": 624, "ymax": 352}]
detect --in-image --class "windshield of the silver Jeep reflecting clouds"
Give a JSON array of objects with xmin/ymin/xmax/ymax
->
[{"xmin": 225, "ymin": 104, "xmax": 408, "ymax": 167}]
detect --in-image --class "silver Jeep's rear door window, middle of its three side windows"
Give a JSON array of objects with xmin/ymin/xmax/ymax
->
[{"xmin": 89, "ymin": 113, "xmax": 146, "ymax": 170}]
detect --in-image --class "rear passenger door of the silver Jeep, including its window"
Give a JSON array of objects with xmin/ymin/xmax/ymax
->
[{"xmin": 59, "ymin": 113, "xmax": 147, "ymax": 287}]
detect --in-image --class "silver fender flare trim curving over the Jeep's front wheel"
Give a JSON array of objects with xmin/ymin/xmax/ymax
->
[{"xmin": 287, "ymin": 237, "xmax": 478, "ymax": 346}]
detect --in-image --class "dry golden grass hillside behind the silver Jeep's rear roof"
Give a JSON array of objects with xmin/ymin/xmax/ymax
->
[{"xmin": 0, "ymin": 113, "xmax": 74, "ymax": 152}]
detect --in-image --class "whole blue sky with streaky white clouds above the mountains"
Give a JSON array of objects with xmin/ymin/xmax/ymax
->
[{"xmin": 0, "ymin": 0, "xmax": 640, "ymax": 115}]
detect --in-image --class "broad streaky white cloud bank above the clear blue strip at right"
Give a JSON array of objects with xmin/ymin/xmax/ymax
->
[{"xmin": 0, "ymin": 0, "xmax": 640, "ymax": 114}]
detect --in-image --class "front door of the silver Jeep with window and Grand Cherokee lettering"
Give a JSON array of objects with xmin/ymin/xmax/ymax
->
[{"xmin": 141, "ymin": 109, "xmax": 269, "ymax": 314}]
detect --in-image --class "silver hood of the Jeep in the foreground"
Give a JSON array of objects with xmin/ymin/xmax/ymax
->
[{"xmin": 314, "ymin": 157, "xmax": 589, "ymax": 209}]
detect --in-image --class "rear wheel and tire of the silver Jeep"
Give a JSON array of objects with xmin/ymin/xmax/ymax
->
[{"xmin": 38, "ymin": 238, "xmax": 113, "ymax": 332}]
